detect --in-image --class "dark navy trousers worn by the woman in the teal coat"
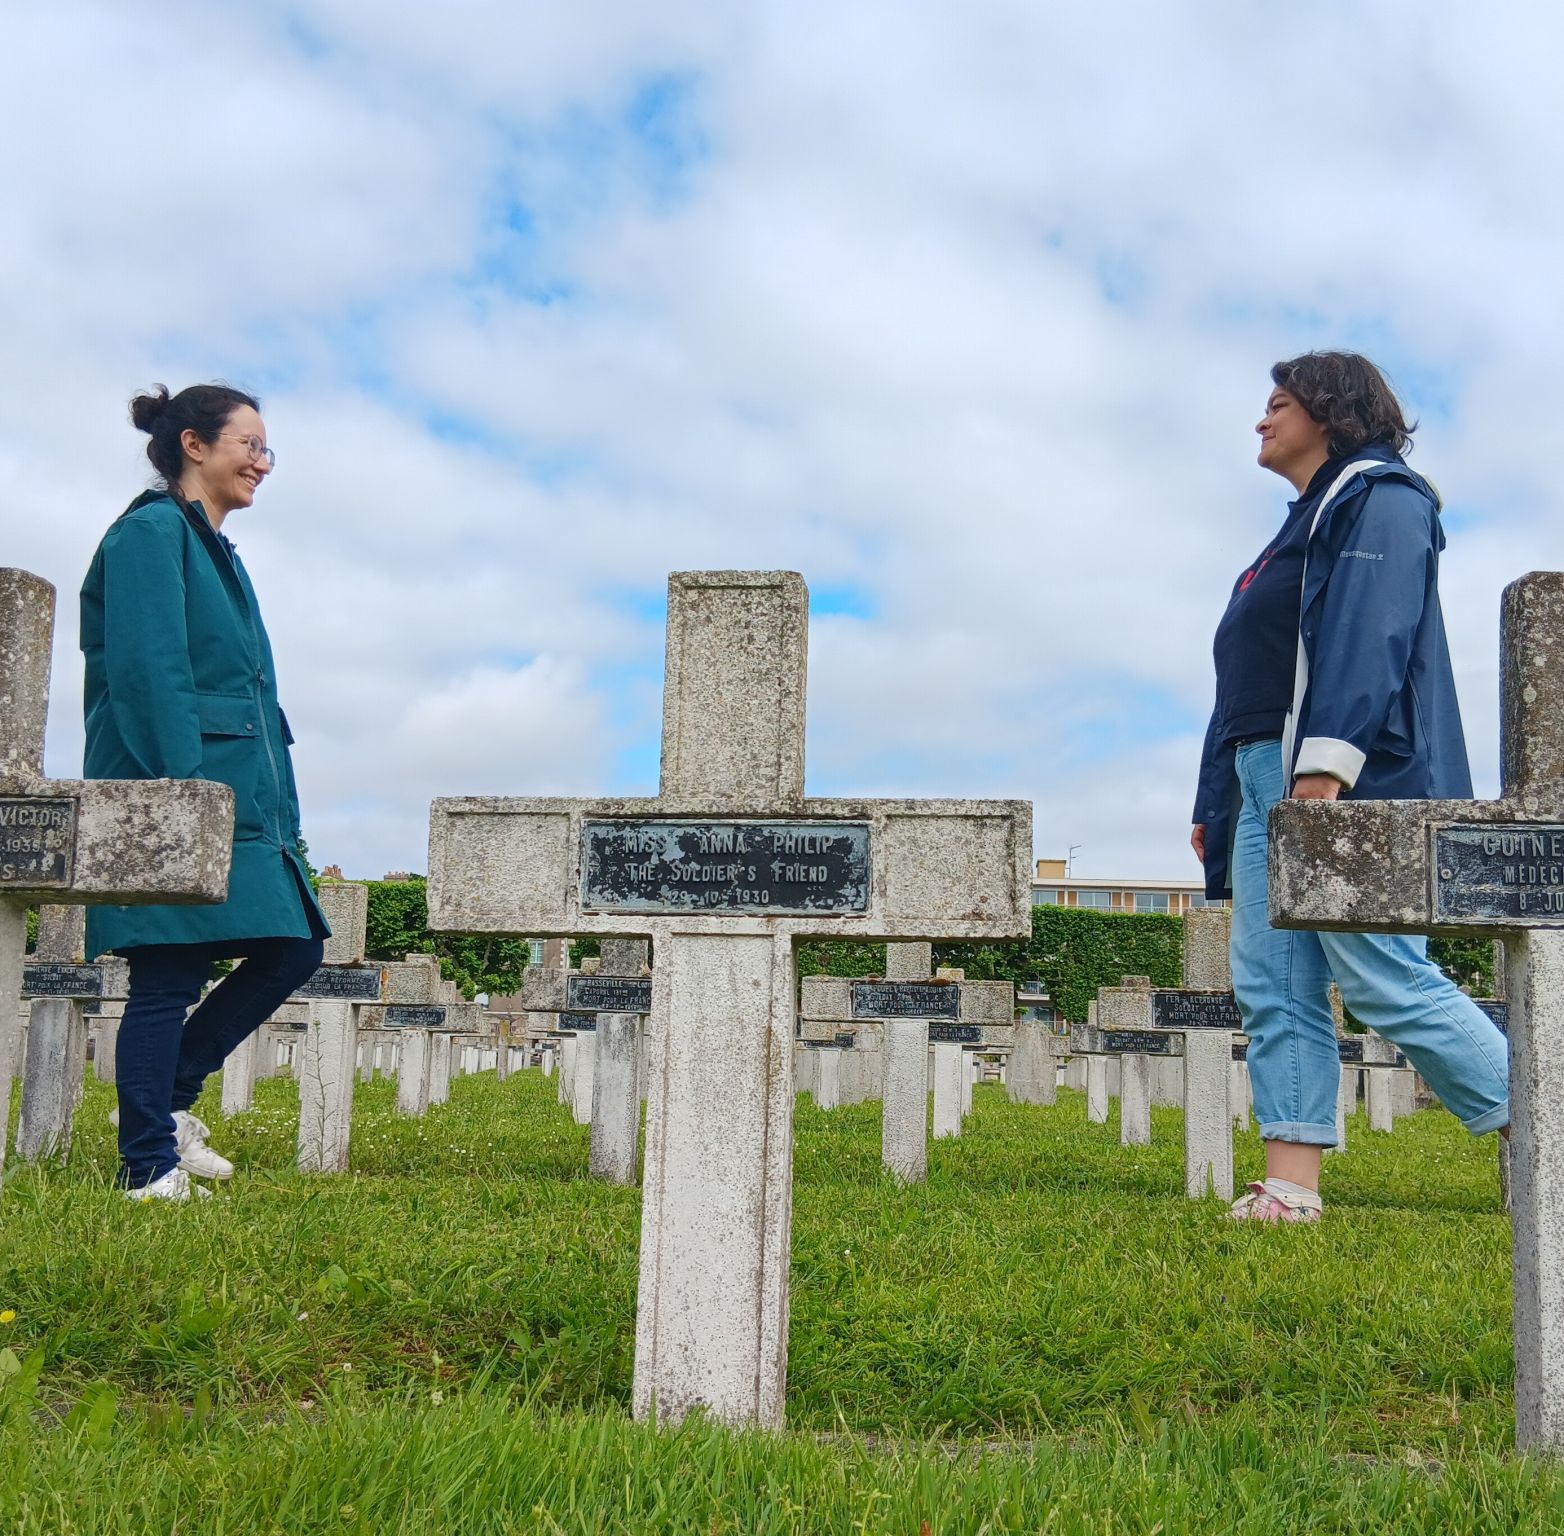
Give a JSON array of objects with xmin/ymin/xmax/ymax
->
[{"xmin": 114, "ymin": 938, "xmax": 325, "ymax": 1189}]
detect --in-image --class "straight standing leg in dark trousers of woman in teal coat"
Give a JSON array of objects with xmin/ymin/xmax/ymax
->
[{"xmin": 114, "ymin": 945, "xmax": 211, "ymax": 1189}]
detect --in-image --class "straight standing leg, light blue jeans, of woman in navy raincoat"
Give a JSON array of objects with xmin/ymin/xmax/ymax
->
[{"xmin": 1231, "ymin": 741, "xmax": 1342, "ymax": 1189}]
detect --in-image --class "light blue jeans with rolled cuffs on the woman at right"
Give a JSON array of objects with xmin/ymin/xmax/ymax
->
[{"xmin": 1232, "ymin": 741, "xmax": 1509, "ymax": 1147}]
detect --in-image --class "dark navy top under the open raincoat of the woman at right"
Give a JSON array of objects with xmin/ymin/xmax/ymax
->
[{"xmin": 1212, "ymin": 458, "xmax": 1345, "ymax": 741}]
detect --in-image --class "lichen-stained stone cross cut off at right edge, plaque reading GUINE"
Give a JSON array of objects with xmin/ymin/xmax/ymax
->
[{"xmin": 1270, "ymin": 571, "xmax": 1564, "ymax": 1452}]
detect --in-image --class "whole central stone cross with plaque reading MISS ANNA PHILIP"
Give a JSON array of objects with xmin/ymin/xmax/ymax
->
[{"xmin": 429, "ymin": 571, "xmax": 1031, "ymax": 1427}]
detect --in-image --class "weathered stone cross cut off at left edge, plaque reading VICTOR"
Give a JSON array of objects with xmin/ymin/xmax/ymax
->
[{"xmin": 0, "ymin": 569, "xmax": 233, "ymax": 1156}]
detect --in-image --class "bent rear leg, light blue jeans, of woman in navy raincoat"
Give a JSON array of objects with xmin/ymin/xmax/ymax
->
[{"xmin": 1320, "ymin": 934, "xmax": 1509, "ymax": 1136}]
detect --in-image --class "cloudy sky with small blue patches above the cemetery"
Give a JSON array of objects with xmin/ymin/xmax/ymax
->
[{"xmin": 0, "ymin": 0, "xmax": 1564, "ymax": 877}]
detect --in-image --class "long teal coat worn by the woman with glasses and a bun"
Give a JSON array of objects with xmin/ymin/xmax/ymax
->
[{"xmin": 81, "ymin": 491, "xmax": 330, "ymax": 956}]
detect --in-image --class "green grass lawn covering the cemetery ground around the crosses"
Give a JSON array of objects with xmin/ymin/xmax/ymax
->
[{"xmin": 0, "ymin": 1073, "xmax": 1564, "ymax": 1536}]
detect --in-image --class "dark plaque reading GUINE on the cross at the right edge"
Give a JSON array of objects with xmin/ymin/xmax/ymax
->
[{"xmin": 1433, "ymin": 823, "xmax": 1564, "ymax": 928}]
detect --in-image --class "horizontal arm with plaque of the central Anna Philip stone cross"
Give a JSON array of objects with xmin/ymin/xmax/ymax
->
[{"xmin": 429, "ymin": 796, "xmax": 1032, "ymax": 940}]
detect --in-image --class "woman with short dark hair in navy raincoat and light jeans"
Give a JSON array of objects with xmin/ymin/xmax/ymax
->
[{"xmin": 1190, "ymin": 352, "xmax": 1509, "ymax": 1222}]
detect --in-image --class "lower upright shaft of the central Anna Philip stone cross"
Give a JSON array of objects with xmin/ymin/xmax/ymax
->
[{"xmin": 633, "ymin": 931, "xmax": 798, "ymax": 1425}]
